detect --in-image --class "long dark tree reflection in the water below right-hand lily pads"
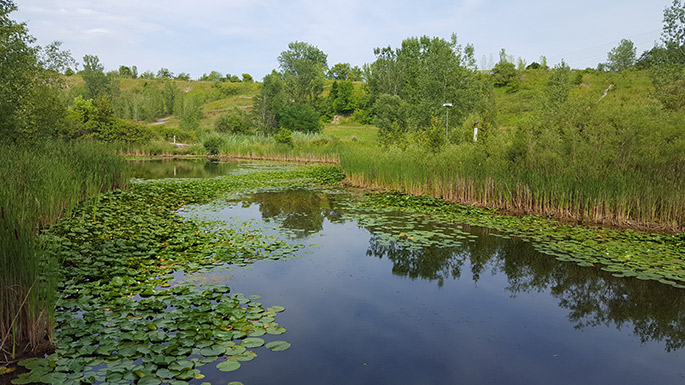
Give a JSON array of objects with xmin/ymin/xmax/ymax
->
[{"xmin": 367, "ymin": 222, "xmax": 685, "ymax": 351}]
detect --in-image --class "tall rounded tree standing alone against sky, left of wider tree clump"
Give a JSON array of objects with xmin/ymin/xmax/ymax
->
[{"xmin": 278, "ymin": 41, "xmax": 328, "ymax": 105}]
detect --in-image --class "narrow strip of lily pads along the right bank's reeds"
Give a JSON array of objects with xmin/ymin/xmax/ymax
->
[{"xmin": 363, "ymin": 192, "xmax": 685, "ymax": 288}]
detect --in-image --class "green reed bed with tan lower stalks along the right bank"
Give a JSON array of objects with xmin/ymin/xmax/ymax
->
[{"xmin": 341, "ymin": 146, "xmax": 685, "ymax": 232}]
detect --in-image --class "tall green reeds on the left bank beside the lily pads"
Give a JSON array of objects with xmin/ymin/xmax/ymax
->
[{"xmin": 0, "ymin": 142, "xmax": 126, "ymax": 361}]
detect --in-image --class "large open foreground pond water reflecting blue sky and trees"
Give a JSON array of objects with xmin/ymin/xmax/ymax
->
[{"xmin": 168, "ymin": 180, "xmax": 685, "ymax": 384}]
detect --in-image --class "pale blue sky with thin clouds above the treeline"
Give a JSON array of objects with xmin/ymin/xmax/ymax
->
[{"xmin": 11, "ymin": 0, "xmax": 672, "ymax": 80}]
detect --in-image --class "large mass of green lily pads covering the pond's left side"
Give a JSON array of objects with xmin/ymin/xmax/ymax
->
[{"xmin": 13, "ymin": 167, "xmax": 339, "ymax": 385}]
